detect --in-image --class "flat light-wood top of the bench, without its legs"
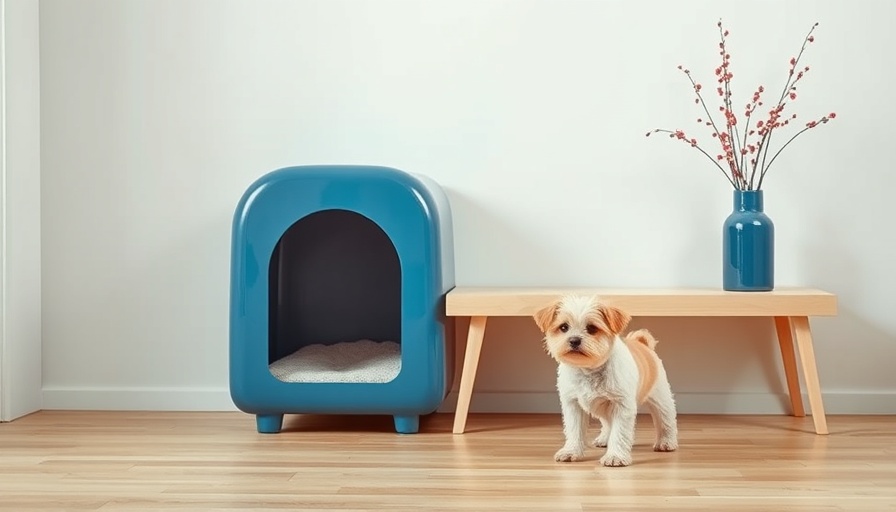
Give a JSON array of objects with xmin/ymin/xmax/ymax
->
[{"xmin": 445, "ymin": 286, "xmax": 837, "ymax": 316}]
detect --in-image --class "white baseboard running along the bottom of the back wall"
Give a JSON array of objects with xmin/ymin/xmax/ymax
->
[{"xmin": 43, "ymin": 386, "xmax": 896, "ymax": 414}]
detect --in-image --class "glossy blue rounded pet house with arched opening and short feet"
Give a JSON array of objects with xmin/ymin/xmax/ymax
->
[{"xmin": 230, "ymin": 165, "xmax": 454, "ymax": 433}]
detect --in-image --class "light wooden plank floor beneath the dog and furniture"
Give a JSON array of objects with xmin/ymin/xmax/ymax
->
[{"xmin": 0, "ymin": 412, "xmax": 896, "ymax": 512}]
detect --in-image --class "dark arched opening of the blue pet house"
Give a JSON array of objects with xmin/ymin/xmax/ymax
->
[{"xmin": 268, "ymin": 210, "xmax": 401, "ymax": 383}]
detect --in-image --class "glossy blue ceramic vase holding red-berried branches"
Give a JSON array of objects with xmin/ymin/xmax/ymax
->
[{"xmin": 722, "ymin": 190, "xmax": 775, "ymax": 292}]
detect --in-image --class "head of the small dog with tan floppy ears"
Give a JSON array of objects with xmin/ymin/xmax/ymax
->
[{"xmin": 534, "ymin": 295, "xmax": 631, "ymax": 368}]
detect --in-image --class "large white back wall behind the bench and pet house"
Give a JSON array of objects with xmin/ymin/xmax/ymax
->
[{"xmin": 41, "ymin": 0, "xmax": 896, "ymax": 413}]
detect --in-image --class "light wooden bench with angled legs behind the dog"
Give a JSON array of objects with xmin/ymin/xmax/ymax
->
[{"xmin": 445, "ymin": 286, "xmax": 837, "ymax": 434}]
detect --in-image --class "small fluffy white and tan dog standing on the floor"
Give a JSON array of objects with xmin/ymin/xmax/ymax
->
[{"xmin": 534, "ymin": 295, "xmax": 678, "ymax": 466}]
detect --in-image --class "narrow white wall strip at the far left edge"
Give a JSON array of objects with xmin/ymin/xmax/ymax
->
[{"xmin": 0, "ymin": 0, "xmax": 42, "ymax": 421}]
